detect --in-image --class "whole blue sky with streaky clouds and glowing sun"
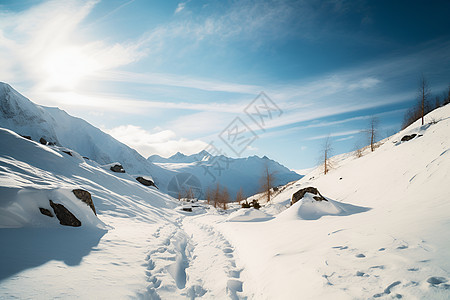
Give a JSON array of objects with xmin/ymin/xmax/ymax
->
[{"xmin": 0, "ymin": 0, "xmax": 450, "ymax": 169}]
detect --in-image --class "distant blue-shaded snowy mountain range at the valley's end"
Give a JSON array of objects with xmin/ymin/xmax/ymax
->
[{"xmin": 148, "ymin": 150, "xmax": 302, "ymax": 198}]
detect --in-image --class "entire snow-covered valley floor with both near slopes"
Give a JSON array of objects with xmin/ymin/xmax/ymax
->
[{"xmin": 0, "ymin": 105, "xmax": 450, "ymax": 299}]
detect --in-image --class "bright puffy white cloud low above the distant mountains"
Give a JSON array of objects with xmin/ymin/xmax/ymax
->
[{"xmin": 103, "ymin": 125, "xmax": 208, "ymax": 157}]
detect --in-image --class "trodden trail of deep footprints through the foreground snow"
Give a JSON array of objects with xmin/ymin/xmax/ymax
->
[{"xmin": 139, "ymin": 216, "xmax": 247, "ymax": 299}]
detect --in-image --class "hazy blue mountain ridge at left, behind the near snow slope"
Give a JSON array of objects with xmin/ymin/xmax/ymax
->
[{"xmin": 0, "ymin": 82, "xmax": 174, "ymax": 189}]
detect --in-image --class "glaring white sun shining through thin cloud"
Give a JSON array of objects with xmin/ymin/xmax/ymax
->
[{"xmin": 42, "ymin": 47, "xmax": 96, "ymax": 90}]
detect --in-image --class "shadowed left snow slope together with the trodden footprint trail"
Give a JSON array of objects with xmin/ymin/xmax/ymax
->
[{"xmin": 0, "ymin": 129, "xmax": 256, "ymax": 299}]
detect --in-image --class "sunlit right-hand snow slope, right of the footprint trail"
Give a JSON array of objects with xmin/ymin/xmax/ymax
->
[{"xmin": 185, "ymin": 105, "xmax": 450, "ymax": 299}]
